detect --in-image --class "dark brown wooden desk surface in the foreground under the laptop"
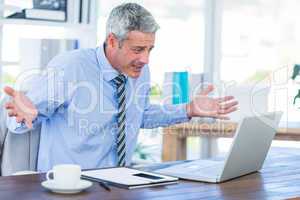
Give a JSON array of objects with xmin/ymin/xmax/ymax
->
[{"xmin": 0, "ymin": 148, "xmax": 300, "ymax": 200}]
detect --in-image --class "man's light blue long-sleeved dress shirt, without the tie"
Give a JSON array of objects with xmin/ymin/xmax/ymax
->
[{"xmin": 7, "ymin": 47, "xmax": 188, "ymax": 172}]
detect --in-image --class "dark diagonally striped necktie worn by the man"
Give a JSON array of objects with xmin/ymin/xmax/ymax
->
[{"xmin": 113, "ymin": 74, "xmax": 126, "ymax": 167}]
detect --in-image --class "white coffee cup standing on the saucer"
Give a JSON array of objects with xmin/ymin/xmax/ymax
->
[{"xmin": 46, "ymin": 164, "xmax": 81, "ymax": 189}]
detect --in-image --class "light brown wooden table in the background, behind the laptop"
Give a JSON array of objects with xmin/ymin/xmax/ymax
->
[{"xmin": 162, "ymin": 122, "xmax": 300, "ymax": 161}]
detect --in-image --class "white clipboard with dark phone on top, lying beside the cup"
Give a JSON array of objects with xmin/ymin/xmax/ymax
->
[{"xmin": 81, "ymin": 167, "xmax": 178, "ymax": 189}]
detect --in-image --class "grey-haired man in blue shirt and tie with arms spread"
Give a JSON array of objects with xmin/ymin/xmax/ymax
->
[{"xmin": 5, "ymin": 3, "xmax": 237, "ymax": 171}]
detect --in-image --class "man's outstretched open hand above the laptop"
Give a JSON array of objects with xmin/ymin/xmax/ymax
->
[{"xmin": 187, "ymin": 85, "xmax": 238, "ymax": 119}]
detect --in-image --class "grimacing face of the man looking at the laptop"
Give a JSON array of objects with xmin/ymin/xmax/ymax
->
[{"xmin": 109, "ymin": 31, "xmax": 155, "ymax": 78}]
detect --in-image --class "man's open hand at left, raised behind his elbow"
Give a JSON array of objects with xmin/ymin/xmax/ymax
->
[{"xmin": 4, "ymin": 87, "xmax": 38, "ymax": 128}]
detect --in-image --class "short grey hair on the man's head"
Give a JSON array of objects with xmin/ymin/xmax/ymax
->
[{"xmin": 106, "ymin": 3, "xmax": 159, "ymax": 42}]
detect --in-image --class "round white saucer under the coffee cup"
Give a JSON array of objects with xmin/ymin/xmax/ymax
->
[{"xmin": 42, "ymin": 180, "xmax": 93, "ymax": 194}]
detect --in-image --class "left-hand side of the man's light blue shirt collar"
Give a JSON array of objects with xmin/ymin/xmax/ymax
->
[{"xmin": 96, "ymin": 44, "xmax": 120, "ymax": 82}]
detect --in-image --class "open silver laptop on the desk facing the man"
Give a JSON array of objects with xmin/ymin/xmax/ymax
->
[{"xmin": 155, "ymin": 112, "xmax": 282, "ymax": 183}]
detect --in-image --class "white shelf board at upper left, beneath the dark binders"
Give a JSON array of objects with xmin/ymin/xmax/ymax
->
[{"xmin": 0, "ymin": 19, "xmax": 94, "ymax": 29}]
